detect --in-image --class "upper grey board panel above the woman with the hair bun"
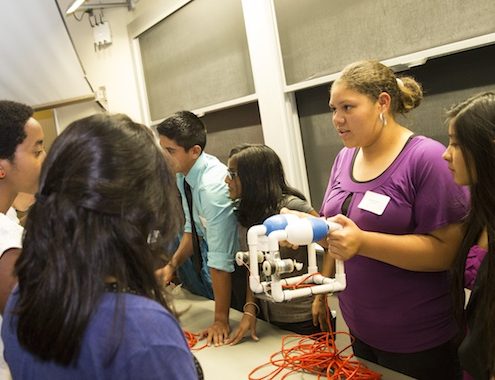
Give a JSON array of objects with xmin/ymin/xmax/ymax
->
[{"xmin": 275, "ymin": 0, "xmax": 495, "ymax": 84}]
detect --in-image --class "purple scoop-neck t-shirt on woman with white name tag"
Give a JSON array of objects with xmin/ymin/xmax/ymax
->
[{"xmin": 320, "ymin": 136, "xmax": 468, "ymax": 353}]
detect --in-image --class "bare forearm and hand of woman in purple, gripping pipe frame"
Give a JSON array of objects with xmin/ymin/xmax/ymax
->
[{"xmin": 327, "ymin": 215, "xmax": 463, "ymax": 272}]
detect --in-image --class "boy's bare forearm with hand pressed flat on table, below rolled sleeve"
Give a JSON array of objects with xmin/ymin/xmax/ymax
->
[{"xmin": 201, "ymin": 268, "xmax": 232, "ymax": 346}]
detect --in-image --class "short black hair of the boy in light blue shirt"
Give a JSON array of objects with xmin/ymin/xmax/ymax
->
[{"xmin": 156, "ymin": 111, "xmax": 206, "ymax": 151}]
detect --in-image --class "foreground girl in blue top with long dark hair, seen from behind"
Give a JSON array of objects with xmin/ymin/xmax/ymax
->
[{"xmin": 2, "ymin": 115, "xmax": 198, "ymax": 380}]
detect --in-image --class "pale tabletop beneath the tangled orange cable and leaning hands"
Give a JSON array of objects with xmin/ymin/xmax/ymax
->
[{"xmin": 172, "ymin": 287, "xmax": 411, "ymax": 380}]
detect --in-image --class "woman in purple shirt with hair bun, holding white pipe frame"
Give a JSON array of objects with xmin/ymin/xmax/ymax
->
[{"xmin": 321, "ymin": 61, "xmax": 467, "ymax": 380}]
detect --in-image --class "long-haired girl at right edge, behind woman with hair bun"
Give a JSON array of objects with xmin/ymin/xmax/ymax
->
[{"xmin": 443, "ymin": 92, "xmax": 495, "ymax": 379}]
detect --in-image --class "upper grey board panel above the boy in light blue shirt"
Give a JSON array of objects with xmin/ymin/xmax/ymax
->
[{"xmin": 139, "ymin": 0, "xmax": 254, "ymax": 120}]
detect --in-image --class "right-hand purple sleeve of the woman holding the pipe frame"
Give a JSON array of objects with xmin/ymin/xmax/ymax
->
[{"xmin": 411, "ymin": 139, "xmax": 469, "ymax": 234}]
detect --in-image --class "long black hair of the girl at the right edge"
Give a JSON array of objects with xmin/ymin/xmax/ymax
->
[{"xmin": 447, "ymin": 92, "xmax": 495, "ymax": 374}]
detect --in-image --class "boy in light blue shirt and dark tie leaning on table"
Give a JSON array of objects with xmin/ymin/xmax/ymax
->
[{"xmin": 157, "ymin": 111, "xmax": 245, "ymax": 345}]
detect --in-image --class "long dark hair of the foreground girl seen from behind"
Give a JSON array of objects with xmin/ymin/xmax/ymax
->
[{"xmin": 14, "ymin": 115, "xmax": 180, "ymax": 365}]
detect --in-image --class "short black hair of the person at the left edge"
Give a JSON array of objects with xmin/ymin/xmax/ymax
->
[{"xmin": 0, "ymin": 100, "xmax": 33, "ymax": 161}]
